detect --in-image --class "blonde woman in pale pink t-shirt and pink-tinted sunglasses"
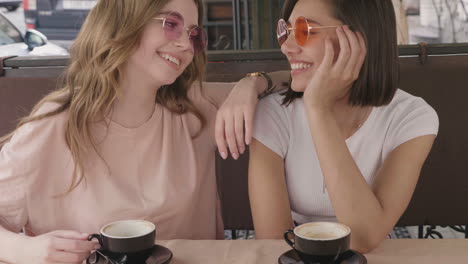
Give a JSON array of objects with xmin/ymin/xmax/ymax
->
[{"xmin": 0, "ymin": 0, "xmax": 282, "ymax": 264}]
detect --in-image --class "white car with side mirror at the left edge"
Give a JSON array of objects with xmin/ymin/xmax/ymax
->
[{"xmin": 0, "ymin": 13, "xmax": 68, "ymax": 57}]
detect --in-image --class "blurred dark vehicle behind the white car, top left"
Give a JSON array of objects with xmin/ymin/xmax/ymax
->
[{"xmin": 23, "ymin": 0, "xmax": 97, "ymax": 40}]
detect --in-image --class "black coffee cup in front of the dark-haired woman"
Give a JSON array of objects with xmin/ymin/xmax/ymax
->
[{"xmin": 284, "ymin": 222, "xmax": 351, "ymax": 264}]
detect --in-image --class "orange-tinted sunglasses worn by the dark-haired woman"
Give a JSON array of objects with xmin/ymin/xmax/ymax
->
[{"xmin": 276, "ymin": 16, "xmax": 341, "ymax": 47}]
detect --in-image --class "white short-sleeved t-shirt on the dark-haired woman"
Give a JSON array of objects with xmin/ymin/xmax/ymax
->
[{"xmin": 254, "ymin": 90, "xmax": 439, "ymax": 223}]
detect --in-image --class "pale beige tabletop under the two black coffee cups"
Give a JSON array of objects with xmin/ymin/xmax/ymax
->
[{"xmin": 157, "ymin": 239, "xmax": 468, "ymax": 264}]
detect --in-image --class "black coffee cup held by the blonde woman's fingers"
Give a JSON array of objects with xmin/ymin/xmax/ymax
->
[{"xmin": 88, "ymin": 220, "xmax": 156, "ymax": 264}]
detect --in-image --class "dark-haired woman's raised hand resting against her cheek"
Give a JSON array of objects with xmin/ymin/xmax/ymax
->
[{"xmin": 304, "ymin": 26, "xmax": 367, "ymax": 109}]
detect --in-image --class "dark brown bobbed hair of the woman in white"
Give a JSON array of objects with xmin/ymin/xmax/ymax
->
[{"xmin": 282, "ymin": 0, "xmax": 399, "ymax": 106}]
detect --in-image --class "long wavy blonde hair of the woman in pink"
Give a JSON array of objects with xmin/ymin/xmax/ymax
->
[{"xmin": 0, "ymin": 0, "xmax": 206, "ymax": 194}]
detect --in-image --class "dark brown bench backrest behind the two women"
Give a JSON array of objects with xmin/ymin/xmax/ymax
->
[{"xmin": 0, "ymin": 44, "xmax": 468, "ymax": 238}]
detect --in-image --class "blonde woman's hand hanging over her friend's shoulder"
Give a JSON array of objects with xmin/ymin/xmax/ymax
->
[{"xmin": 215, "ymin": 78, "xmax": 258, "ymax": 160}]
